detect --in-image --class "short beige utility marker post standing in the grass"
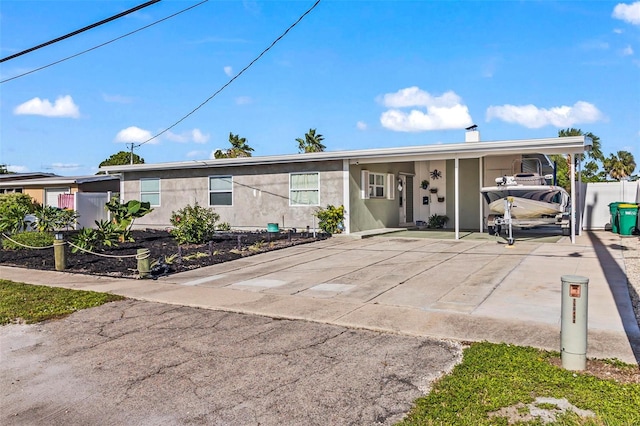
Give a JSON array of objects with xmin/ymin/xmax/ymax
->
[{"xmin": 560, "ymin": 275, "xmax": 589, "ymax": 370}]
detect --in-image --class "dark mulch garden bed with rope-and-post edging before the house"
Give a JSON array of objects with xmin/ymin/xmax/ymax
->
[{"xmin": 0, "ymin": 229, "xmax": 328, "ymax": 278}]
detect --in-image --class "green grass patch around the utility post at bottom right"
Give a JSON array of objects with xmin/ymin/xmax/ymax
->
[{"xmin": 400, "ymin": 342, "xmax": 640, "ymax": 426}]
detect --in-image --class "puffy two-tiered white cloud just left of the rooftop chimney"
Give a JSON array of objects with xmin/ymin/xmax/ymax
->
[{"xmin": 378, "ymin": 86, "xmax": 473, "ymax": 132}]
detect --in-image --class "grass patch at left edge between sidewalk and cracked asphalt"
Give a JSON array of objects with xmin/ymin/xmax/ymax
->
[{"xmin": 0, "ymin": 280, "xmax": 124, "ymax": 325}]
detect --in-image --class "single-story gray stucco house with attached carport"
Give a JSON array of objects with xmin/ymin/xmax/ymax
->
[{"xmin": 101, "ymin": 130, "xmax": 591, "ymax": 243}]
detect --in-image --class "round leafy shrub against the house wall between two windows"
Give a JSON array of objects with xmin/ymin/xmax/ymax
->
[{"xmin": 170, "ymin": 203, "xmax": 220, "ymax": 244}]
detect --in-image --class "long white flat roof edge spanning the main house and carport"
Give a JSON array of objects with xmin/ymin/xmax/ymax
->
[{"xmin": 100, "ymin": 136, "xmax": 591, "ymax": 173}]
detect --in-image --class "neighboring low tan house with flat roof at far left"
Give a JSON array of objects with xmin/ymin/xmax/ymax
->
[{"xmin": 0, "ymin": 174, "xmax": 120, "ymax": 208}]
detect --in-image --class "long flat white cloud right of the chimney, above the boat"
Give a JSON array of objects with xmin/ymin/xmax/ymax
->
[{"xmin": 487, "ymin": 101, "xmax": 604, "ymax": 129}]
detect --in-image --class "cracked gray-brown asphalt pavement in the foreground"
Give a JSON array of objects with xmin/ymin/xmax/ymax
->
[{"xmin": 0, "ymin": 300, "xmax": 461, "ymax": 426}]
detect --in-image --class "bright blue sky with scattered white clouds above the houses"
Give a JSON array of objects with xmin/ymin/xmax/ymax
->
[{"xmin": 0, "ymin": 0, "xmax": 640, "ymax": 175}]
